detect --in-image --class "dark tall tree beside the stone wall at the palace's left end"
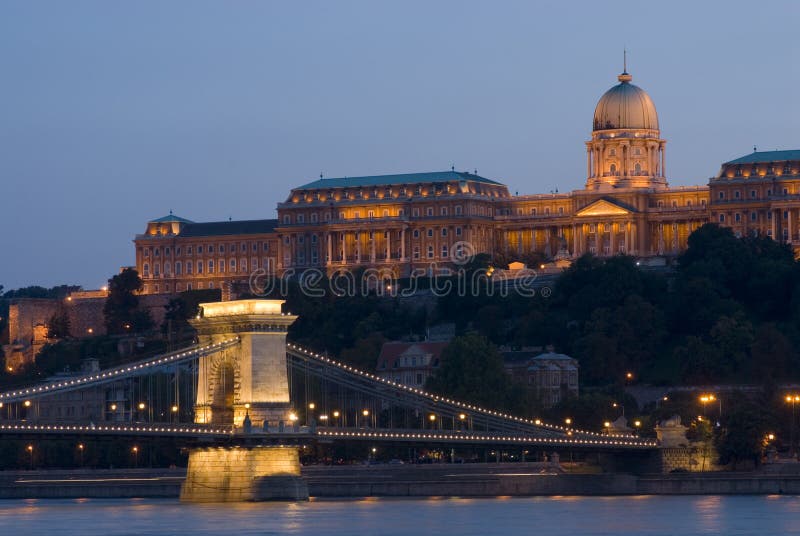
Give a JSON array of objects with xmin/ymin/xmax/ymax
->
[{"xmin": 103, "ymin": 268, "xmax": 147, "ymax": 335}]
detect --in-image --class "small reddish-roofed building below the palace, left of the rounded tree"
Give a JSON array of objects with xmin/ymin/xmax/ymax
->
[{"xmin": 376, "ymin": 341, "xmax": 449, "ymax": 387}]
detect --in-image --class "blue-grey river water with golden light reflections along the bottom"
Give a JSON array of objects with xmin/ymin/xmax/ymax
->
[{"xmin": 0, "ymin": 495, "xmax": 800, "ymax": 536}]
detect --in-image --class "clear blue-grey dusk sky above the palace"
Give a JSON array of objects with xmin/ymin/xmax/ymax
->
[{"xmin": 0, "ymin": 0, "xmax": 800, "ymax": 290}]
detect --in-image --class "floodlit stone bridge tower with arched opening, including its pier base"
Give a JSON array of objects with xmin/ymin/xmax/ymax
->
[{"xmin": 181, "ymin": 300, "xmax": 308, "ymax": 502}]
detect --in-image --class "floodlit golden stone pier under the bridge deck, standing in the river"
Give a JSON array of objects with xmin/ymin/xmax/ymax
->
[{"xmin": 181, "ymin": 446, "xmax": 308, "ymax": 502}]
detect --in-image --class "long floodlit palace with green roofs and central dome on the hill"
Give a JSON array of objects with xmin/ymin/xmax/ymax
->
[{"xmin": 134, "ymin": 68, "xmax": 800, "ymax": 293}]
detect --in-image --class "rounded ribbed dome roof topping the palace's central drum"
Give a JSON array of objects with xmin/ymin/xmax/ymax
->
[{"xmin": 592, "ymin": 72, "xmax": 658, "ymax": 130}]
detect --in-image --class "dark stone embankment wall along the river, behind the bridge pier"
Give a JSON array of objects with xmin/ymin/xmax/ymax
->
[{"xmin": 0, "ymin": 463, "xmax": 800, "ymax": 499}]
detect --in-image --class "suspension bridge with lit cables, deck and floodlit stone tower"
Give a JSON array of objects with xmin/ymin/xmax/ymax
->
[{"xmin": 0, "ymin": 300, "xmax": 657, "ymax": 501}]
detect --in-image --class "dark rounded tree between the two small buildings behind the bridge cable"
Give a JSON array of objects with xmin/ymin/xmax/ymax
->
[{"xmin": 427, "ymin": 332, "xmax": 526, "ymax": 412}]
